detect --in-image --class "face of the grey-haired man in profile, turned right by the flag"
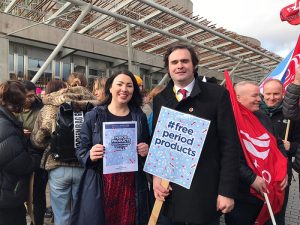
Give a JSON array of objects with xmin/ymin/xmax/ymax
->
[{"xmin": 237, "ymin": 84, "xmax": 260, "ymax": 112}]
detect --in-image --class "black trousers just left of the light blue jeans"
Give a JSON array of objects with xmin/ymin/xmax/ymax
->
[{"xmin": 33, "ymin": 169, "xmax": 48, "ymax": 225}]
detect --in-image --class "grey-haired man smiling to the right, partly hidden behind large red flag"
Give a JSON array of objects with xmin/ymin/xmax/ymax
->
[{"xmin": 225, "ymin": 81, "xmax": 287, "ymax": 225}]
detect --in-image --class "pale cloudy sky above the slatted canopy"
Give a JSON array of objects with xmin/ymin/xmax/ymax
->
[{"xmin": 192, "ymin": 0, "xmax": 300, "ymax": 57}]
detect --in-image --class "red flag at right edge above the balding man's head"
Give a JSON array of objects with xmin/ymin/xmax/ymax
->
[{"xmin": 283, "ymin": 35, "xmax": 300, "ymax": 90}]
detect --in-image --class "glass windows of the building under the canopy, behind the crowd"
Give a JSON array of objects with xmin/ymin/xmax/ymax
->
[{"xmin": 8, "ymin": 42, "xmax": 159, "ymax": 87}]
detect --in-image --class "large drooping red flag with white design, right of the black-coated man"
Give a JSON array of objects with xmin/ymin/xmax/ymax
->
[{"xmin": 224, "ymin": 71, "xmax": 287, "ymax": 225}]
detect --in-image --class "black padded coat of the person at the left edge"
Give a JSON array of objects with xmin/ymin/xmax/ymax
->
[{"xmin": 0, "ymin": 106, "xmax": 36, "ymax": 208}]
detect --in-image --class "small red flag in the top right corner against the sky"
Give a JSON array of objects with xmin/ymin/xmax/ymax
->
[{"xmin": 280, "ymin": 0, "xmax": 300, "ymax": 25}]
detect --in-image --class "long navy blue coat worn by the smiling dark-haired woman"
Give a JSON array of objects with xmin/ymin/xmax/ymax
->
[{"xmin": 71, "ymin": 106, "xmax": 150, "ymax": 225}]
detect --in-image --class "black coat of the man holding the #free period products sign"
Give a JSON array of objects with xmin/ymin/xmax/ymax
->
[{"xmin": 153, "ymin": 78, "xmax": 241, "ymax": 224}]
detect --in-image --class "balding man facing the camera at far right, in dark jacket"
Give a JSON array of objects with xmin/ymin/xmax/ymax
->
[{"xmin": 260, "ymin": 79, "xmax": 300, "ymax": 225}]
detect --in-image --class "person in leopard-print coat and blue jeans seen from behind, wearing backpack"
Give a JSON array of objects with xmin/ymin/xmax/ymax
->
[{"xmin": 31, "ymin": 73, "xmax": 99, "ymax": 225}]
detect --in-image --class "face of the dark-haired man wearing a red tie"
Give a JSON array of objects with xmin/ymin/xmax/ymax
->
[{"xmin": 168, "ymin": 49, "xmax": 194, "ymax": 87}]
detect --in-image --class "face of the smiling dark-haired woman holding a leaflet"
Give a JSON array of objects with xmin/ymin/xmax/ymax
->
[{"xmin": 109, "ymin": 74, "xmax": 134, "ymax": 104}]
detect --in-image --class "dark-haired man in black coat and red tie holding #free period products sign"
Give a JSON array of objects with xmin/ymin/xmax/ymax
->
[{"xmin": 153, "ymin": 45, "xmax": 240, "ymax": 225}]
